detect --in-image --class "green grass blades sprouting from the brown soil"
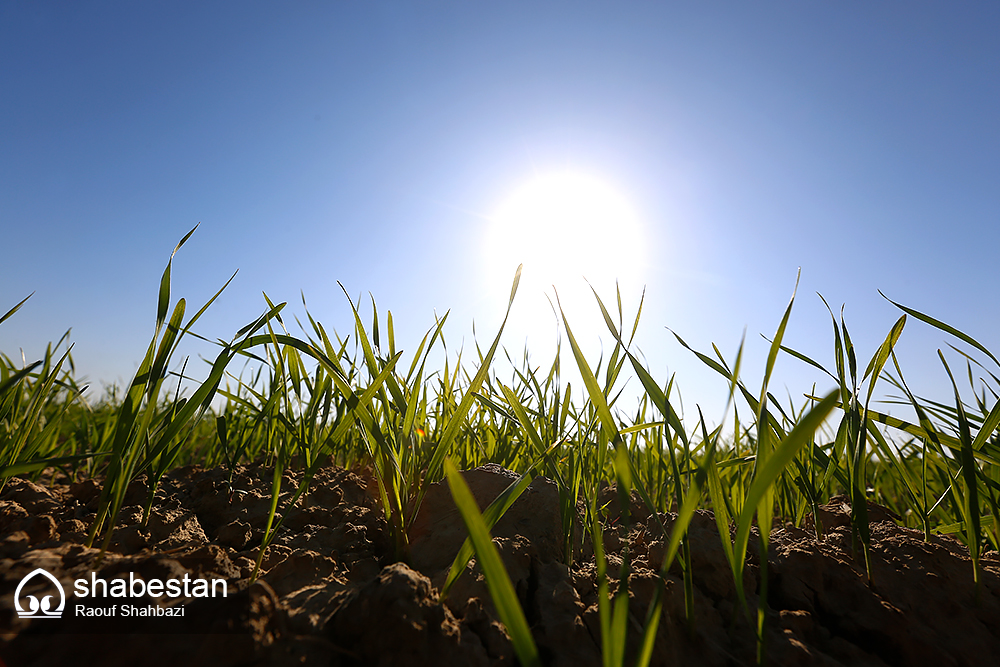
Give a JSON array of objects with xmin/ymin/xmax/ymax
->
[{"xmin": 0, "ymin": 230, "xmax": 1000, "ymax": 666}]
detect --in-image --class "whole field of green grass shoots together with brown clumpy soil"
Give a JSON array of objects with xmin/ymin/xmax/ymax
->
[{"xmin": 0, "ymin": 230, "xmax": 1000, "ymax": 666}]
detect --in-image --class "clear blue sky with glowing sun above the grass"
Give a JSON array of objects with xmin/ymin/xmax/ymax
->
[{"xmin": 0, "ymin": 1, "xmax": 1000, "ymax": 422}]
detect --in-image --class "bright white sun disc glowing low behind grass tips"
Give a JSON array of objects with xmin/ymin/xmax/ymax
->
[{"xmin": 484, "ymin": 171, "xmax": 646, "ymax": 354}]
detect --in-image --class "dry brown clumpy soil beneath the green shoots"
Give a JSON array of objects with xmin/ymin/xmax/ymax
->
[{"xmin": 0, "ymin": 465, "xmax": 1000, "ymax": 667}]
